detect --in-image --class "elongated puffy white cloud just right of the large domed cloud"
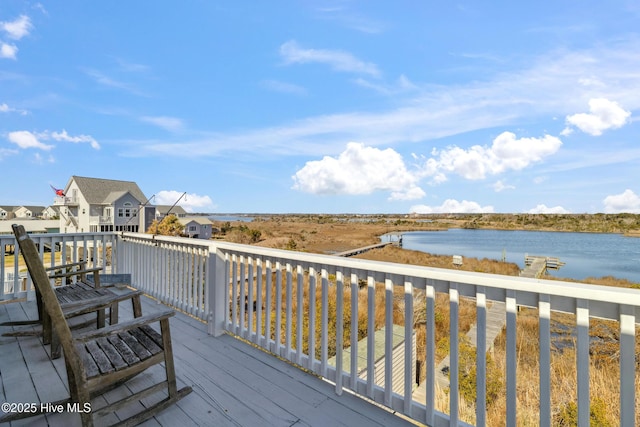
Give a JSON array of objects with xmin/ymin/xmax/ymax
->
[{"xmin": 424, "ymin": 132, "xmax": 562, "ymax": 182}]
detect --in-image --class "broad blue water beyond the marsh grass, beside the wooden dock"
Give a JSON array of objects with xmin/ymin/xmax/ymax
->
[{"xmin": 402, "ymin": 229, "xmax": 640, "ymax": 283}]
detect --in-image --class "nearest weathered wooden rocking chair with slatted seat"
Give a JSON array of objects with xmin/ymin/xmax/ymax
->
[{"xmin": 0, "ymin": 225, "xmax": 191, "ymax": 426}]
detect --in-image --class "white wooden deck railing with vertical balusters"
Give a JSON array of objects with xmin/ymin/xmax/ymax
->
[{"xmin": 0, "ymin": 233, "xmax": 640, "ymax": 426}]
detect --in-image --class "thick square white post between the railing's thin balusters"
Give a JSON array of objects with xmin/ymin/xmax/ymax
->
[{"xmin": 206, "ymin": 248, "xmax": 227, "ymax": 337}]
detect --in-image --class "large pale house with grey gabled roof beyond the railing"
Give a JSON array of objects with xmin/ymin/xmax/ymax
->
[{"xmin": 54, "ymin": 176, "xmax": 155, "ymax": 233}]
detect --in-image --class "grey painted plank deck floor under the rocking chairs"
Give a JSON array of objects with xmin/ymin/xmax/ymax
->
[{"xmin": 0, "ymin": 298, "xmax": 414, "ymax": 427}]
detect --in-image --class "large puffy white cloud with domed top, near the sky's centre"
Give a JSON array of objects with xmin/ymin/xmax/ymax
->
[{"xmin": 292, "ymin": 142, "xmax": 425, "ymax": 200}]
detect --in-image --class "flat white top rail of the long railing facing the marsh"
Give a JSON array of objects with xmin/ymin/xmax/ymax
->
[{"xmin": 119, "ymin": 233, "xmax": 640, "ymax": 307}]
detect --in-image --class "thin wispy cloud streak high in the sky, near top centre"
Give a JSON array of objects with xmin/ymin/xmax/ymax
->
[{"xmin": 280, "ymin": 40, "xmax": 380, "ymax": 77}]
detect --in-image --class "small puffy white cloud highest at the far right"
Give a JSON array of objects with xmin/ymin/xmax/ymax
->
[{"xmin": 563, "ymin": 98, "xmax": 631, "ymax": 136}]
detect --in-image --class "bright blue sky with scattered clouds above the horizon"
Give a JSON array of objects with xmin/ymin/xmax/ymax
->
[{"xmin": 0, "ymin": 0, "xmax": 640, "ymax": 213}]
